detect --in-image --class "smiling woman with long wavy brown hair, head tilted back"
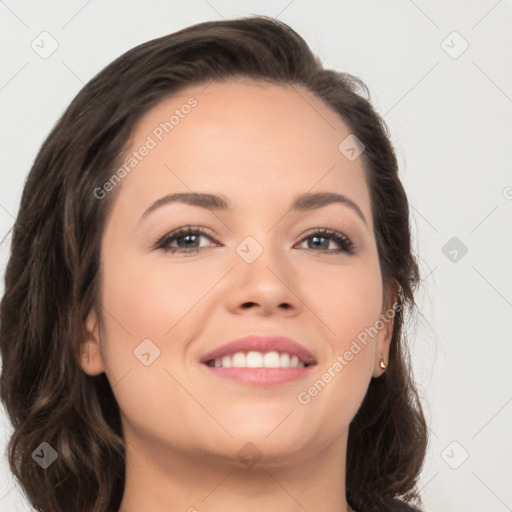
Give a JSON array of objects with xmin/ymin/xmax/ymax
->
[{"xmin": 0, "ymin": 17, "xmax": 427, "ymax": 512}]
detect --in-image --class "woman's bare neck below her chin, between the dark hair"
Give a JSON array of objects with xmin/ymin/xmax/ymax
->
[{"xmin": 119, "ymin": 430, "xmax": 351, "ymax": 512}]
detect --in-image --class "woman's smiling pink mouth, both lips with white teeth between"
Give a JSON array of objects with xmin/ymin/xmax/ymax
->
[{"xmin": 200, "ymin": 336, "xmax": 316, "ymax": 385}]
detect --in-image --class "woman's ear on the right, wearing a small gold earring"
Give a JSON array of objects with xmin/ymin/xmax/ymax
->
[{"xmin": 372, "ymin": 279, "xmax": 401, "ymax": 377}]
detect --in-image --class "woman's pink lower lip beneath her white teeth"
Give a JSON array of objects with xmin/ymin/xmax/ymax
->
[{"xmin": 203, "ymin": 365, "xmax": 314, "ymax": 386}]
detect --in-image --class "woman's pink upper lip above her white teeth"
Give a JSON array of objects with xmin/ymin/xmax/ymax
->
[{"xmin": 200, "ymin": 335, "xmax": 316, "ymax": 364}]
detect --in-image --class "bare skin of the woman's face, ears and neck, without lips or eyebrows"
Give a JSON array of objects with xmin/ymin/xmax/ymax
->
[{"xmin": 82, "ymin": 79, "xmax": 392, "ymax": 512}]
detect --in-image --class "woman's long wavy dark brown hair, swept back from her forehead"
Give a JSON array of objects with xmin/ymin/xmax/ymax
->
[{"xmin": 0, "ymin": 16, "xmax": 427, "ymax": 512}]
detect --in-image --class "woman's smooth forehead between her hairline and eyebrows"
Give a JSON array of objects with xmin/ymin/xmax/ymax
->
[{"xmin": 113, "ymin": 79, "xmax": 369, "ymax": 223}]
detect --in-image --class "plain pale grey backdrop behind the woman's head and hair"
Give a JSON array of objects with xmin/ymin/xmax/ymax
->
[{"xmin": 0, "ymin": 0, "xmax": 512, "ymax": 512}]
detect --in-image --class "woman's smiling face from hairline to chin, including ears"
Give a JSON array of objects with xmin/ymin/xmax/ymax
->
[{"xmin": 82, "ymin": 80, "xmax": 392, "ymax": 465}]
